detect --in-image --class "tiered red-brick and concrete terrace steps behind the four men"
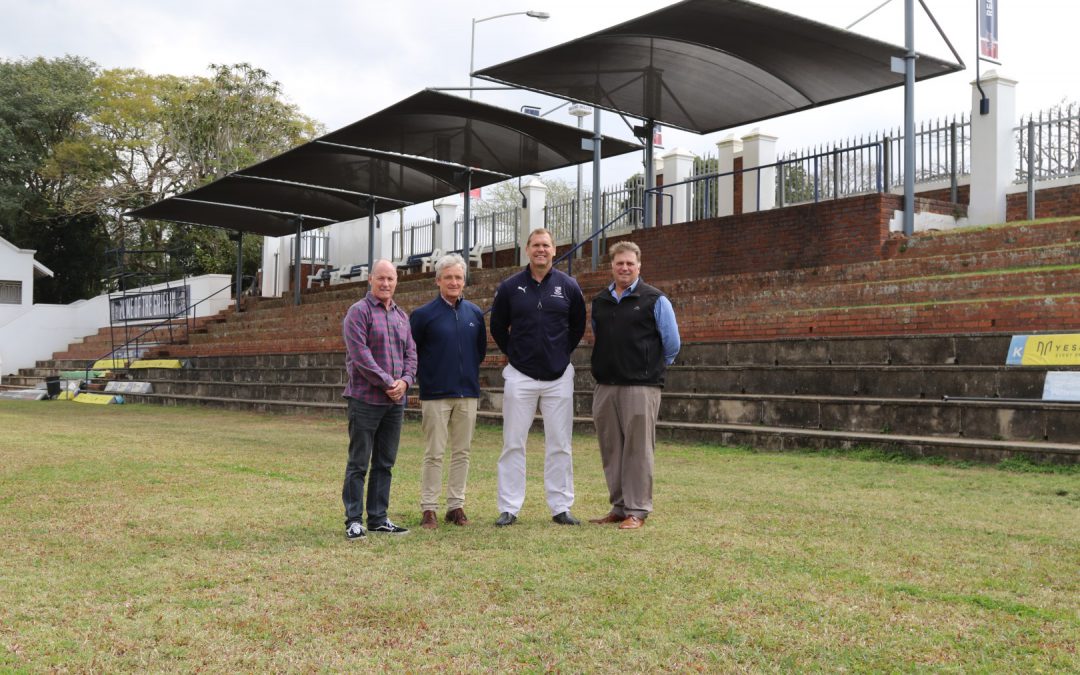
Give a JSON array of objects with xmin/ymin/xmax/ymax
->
[{"xmin": 16, "ymin": 218, "xmax": 1080, "ymax": 461}]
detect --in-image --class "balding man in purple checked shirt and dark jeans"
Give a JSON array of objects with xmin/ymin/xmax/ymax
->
[{"xmin": 341, "ymin": 260, "xmax": 416, "ymax": 539}]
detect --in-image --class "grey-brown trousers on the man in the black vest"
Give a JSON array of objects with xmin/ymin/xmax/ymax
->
[{"xmin": 593, "ymin": 384, "xmax": 661, "ymax": 518}]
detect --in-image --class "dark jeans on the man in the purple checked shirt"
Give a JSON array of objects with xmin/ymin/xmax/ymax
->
[{"xmin": 341, "ymin": 399, "xmax": 405, "ymax": 529}]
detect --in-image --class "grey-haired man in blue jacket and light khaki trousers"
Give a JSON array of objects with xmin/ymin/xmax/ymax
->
[{"xmin": 409, "ymin": 253, "xmax": 487, "ymax": 529}]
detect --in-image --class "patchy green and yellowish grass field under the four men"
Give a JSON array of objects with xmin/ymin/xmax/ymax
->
[{"xmin": 0, "ymin": 402, "xmax": 1080, "ymax": 672}]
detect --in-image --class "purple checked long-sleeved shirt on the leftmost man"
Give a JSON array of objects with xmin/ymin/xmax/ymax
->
[{"xmin": 341, "ymin": 293, "xmax": 416, "ymax": 405}]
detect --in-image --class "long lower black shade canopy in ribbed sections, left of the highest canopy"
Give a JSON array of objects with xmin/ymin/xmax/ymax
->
[{"xmin": 126, "ymin": 90, "xmax": 640, "ymax": 237}]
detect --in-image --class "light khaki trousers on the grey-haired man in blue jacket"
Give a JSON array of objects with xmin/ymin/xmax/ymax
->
[{"xmin": 420, "ymin": 399, "xmax": 477, "ymax": 511}]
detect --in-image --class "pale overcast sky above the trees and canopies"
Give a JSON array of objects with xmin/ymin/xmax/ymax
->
[{"xmin": 0, "ymin": 0, "xmax": 1080, "ymax": 190}]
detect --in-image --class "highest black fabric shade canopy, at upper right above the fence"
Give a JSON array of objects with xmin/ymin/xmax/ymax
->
[{"xmin": 474, "ymin": 0, "xmax": 963, "ymax": 133}]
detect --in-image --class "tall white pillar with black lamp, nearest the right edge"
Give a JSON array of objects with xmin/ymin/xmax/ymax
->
[{"xmin": 968, "ymin": 70, "xmax": 1016, "ymax": 225}]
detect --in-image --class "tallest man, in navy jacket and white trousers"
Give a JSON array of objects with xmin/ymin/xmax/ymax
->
[{"xmin": 491, "ymin": 228, "xmax": 585, "ymax": 527}]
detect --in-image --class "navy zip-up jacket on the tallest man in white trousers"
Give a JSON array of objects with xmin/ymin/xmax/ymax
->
[{"xmin": 491, "ymin": 266, "xmax": 585, "ymax": 380}]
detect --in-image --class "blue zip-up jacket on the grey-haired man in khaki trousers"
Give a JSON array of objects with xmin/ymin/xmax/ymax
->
[{"xmin": 409, "ymin": 296, "xmax": 487, "ymax": 401}]
